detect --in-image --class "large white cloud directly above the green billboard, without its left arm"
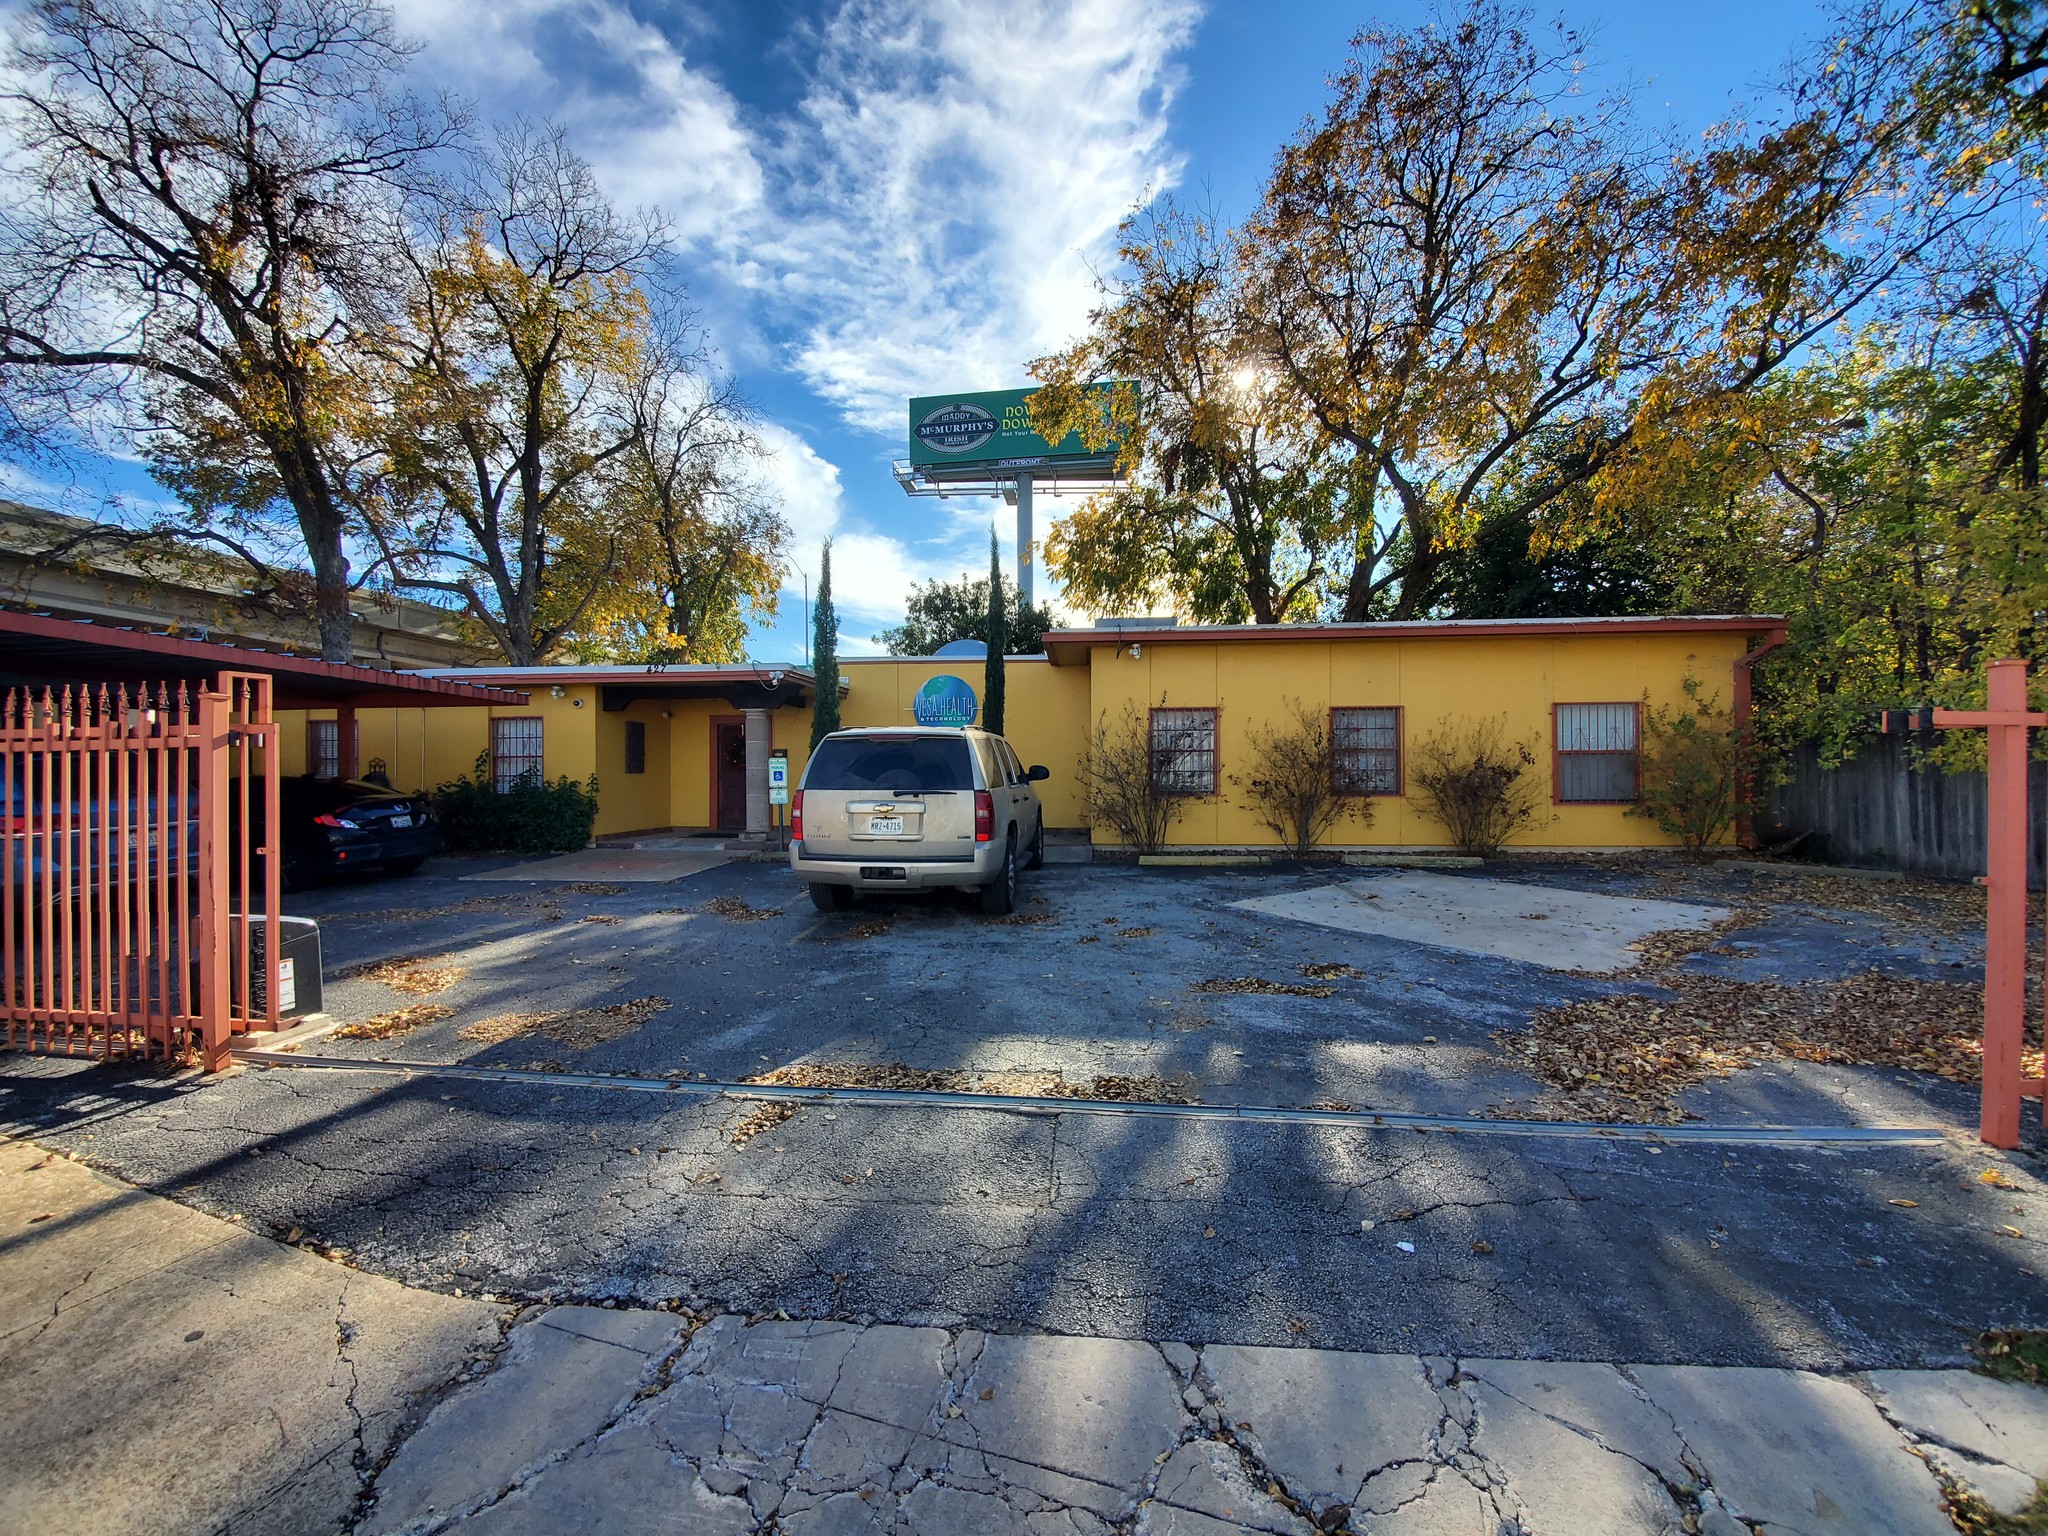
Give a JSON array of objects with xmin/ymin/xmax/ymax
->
[{"xmin": 748, "ymin": 0, "xmax": 1196, "ymax": 436}]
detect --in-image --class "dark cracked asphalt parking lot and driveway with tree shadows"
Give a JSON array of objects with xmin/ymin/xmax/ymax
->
[{"xmin": 0, "ymin": 860, "xmax": 2048, "ymax": 1368}]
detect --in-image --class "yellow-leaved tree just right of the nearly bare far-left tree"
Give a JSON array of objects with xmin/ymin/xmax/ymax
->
[{"xmin": 383, "ymin": 123, "xmax": 664, "ymax": 666}]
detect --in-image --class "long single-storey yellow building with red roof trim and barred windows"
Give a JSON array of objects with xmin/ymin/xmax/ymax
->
[{"xmin": 285, "ymin": 616, "xmax": 1784, "ymax": 848}]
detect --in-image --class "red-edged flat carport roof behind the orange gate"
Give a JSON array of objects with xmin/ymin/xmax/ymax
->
[{"xmin": 0, "ymin": 610, "xmax": 526, "ymax": 709}]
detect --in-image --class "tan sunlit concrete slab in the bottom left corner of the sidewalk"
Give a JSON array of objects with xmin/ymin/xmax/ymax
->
[{"xmin": 0, "ymin": 1141, "xmax": 504, "ymax": 1536}]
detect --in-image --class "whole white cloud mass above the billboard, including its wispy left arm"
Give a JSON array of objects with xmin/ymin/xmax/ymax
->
[{"xmin": 387, "ymin": 0, "xmax": 1198, "ymax": 440}]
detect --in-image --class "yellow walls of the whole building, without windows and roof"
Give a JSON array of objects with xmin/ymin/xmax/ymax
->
[{"xmin": 281, "ymin": 631, "xmax": 1745, "ymax": 848}]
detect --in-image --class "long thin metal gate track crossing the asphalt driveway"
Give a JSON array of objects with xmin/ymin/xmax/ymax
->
[{"xmin": 236, "ymin": 1051, "xmax": 1946, "ymax": 1147}]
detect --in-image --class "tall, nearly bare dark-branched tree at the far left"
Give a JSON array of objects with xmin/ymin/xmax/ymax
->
[{"xmin": 0, "ymin": 0, "xmax": 459, "ymax": 662}]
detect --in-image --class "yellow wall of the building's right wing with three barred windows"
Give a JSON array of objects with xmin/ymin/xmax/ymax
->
[{"xmin": 1061, "ymin": 633, "xmax": 1747, "ymax": 848}]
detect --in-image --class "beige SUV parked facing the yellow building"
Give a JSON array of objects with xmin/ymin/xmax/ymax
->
[{"xmin": 788, "ymin": 725, "xmax": 1049, "ymax": 915}]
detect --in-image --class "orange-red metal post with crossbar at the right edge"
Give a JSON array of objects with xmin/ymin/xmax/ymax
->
[{"xmin": 1933, "ymin": 662, "xmax": 2048, "ymax": 1147}]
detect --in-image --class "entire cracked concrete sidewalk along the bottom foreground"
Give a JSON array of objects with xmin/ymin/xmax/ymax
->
[{"xmin": 0, "ymin": 1143, "xmax": 2048, "ymax": 1536}]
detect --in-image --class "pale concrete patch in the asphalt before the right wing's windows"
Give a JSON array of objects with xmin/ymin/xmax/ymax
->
[{"xmin": 1233, "ymin": 874, "xmax": 1729, "ymax": 971}]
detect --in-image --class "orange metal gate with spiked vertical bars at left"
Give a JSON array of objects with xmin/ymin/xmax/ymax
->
[{"xmin": 0, "ymin": 672, "xmax": 279, "ymax": 1071}]
